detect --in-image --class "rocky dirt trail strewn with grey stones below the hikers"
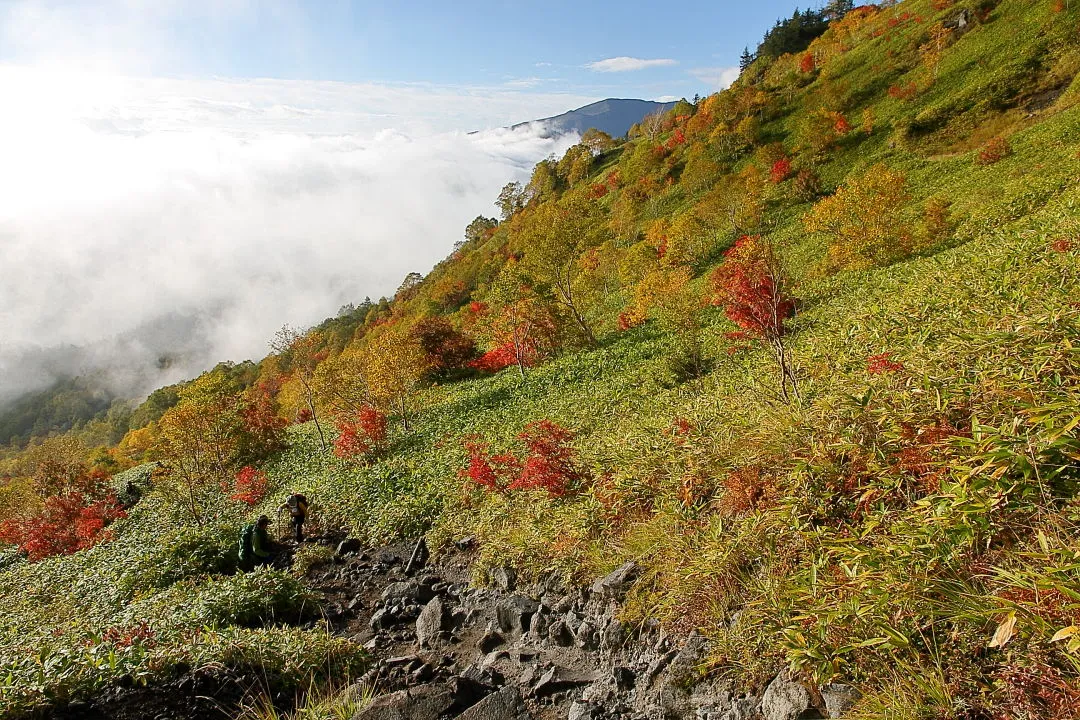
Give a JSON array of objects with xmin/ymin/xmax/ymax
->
[{"xmin": 49, "ymin": 539, "xmax": 858, "ymax": 720}]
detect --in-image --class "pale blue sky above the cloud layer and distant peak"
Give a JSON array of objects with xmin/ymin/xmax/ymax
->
[{"xmin": 0, "ymin": 0, "xmax": 812, "ymax": 114}]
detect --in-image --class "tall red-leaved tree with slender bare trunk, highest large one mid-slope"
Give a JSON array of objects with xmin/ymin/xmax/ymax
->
[{"xmin": 711, "ymin": 235, "xmax": 799, "ymax": 402}]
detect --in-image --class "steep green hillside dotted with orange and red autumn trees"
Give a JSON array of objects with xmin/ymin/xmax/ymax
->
[{"xmin": 0, "ymin": 0, "xmax": 1080, "ymax": 719}]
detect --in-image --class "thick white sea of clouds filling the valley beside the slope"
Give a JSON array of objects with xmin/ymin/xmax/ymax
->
[{"xmin": 0, "ymin": 66, "xmax": 596, "ymax": 400}]
